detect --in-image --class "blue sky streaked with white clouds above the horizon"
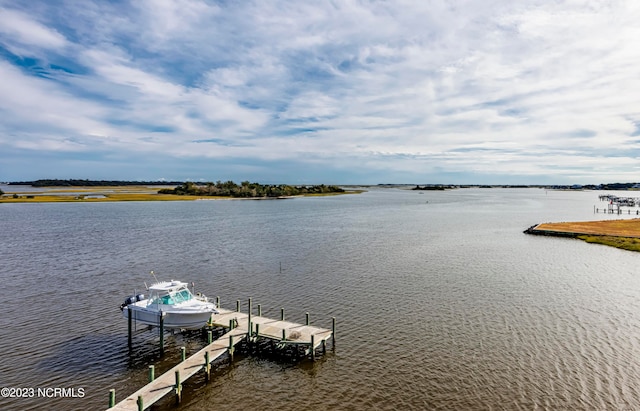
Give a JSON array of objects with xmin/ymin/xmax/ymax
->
[{"xmin": 0, "ymin": 0, "xmax": 640, "ymax": 184}]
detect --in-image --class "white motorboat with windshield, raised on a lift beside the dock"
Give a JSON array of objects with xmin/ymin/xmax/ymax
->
[{"xmin": 120, "ymin": 280, "xmax": 218, "ymax": 330}]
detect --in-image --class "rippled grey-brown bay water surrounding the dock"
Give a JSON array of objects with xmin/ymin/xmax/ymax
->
[{"xmin": 0, "ymin": 189, "xmax": 640, "ymax": 410}]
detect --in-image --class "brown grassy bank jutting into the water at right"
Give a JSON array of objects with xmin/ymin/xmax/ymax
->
[{"xmin": 524, "ymin": 218, "xmax": 640, "ymax": 251}]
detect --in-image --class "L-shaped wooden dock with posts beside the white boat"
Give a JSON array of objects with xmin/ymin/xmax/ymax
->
[{"xmin": 109, "ymin": 299, "xmax": 335, "ymax": 411}]
